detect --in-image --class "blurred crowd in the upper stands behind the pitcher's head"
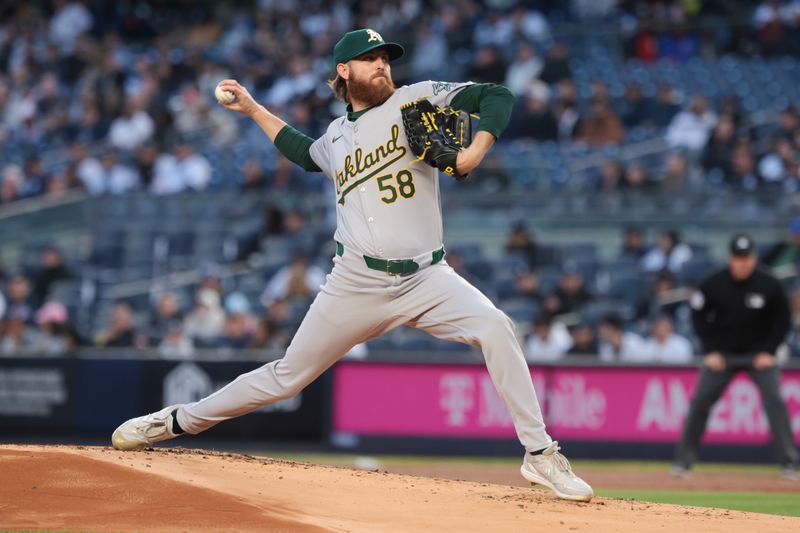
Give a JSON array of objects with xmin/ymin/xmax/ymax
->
[{"xmin": 0, "ymin": 0, "xmax": 800, "ymax": 205}]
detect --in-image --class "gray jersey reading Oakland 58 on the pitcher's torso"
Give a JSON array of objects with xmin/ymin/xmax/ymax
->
[{"xmin": 311, "ymin": 81, "xmax": 468, "ymax": 259}]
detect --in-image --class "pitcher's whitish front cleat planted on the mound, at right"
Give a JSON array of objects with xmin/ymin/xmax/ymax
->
[{"xmin": 520, "ymin": 441, "xmax": 594, "ymax": 502}]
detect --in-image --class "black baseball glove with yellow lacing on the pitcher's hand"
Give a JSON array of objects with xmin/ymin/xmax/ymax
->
[{"xmin": 400, "ymin": 98, "xmax": 472, "ymax": 181}]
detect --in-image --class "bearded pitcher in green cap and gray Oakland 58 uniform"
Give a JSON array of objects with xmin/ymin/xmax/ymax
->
[{"xmin": 112, "ymin": 29, "xmax": 593, "ymax": 501}]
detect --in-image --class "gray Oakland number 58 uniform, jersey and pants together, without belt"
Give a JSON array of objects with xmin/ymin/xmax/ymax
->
[{"xmin": 177, "ymin": 81, "xmax": 552, "ymax": 458}]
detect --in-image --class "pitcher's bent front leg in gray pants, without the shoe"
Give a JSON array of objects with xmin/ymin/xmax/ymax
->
[{"xmin": 409, "ymin": 265, "xmax": 552, "ymax": 451}]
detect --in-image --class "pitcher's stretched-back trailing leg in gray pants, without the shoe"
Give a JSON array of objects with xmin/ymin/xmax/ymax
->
[{"xmin": 177, "ymin": 286, "xmax": 381, "ymax": 433}]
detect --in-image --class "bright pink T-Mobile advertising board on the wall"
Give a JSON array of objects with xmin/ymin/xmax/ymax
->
[{"xmin": 333, "ymin": 362, "xmax": 800, "ymax": 444}]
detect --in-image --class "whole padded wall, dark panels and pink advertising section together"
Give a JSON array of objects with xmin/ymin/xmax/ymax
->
[{"xmin": 0, "ymin": 357, "xmax": 800, "ymax": 462}]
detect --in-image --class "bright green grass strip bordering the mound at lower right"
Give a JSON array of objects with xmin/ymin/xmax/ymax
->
[{"xmin": 597, "ymin": 489, "xmax": 800, "ymax": 516}]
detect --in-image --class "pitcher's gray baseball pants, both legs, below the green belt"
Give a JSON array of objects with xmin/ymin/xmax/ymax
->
[{"xmin": 177, "ymin": 250, "xmax": 552, "ymax": 451}]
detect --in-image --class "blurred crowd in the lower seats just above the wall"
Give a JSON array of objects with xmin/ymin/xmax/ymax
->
[{"xmin": 0, "ymin": 218, "xmax": 800, "ymax": 364}]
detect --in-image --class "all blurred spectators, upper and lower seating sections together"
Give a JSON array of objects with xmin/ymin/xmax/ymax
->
[{"xmin": 0, "ymin": 0, "xmax": 800, "ymax": 363}]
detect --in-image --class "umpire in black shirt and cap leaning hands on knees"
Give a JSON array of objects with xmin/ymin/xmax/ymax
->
[{"xmin": 673, "ymin": 235, "xmax": 798, "ymax": 478}]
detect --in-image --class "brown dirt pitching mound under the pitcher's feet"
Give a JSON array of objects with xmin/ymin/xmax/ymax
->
[{"xmin": 0, "ymin": 446, "xmax": 800, "ymax": 533}]
